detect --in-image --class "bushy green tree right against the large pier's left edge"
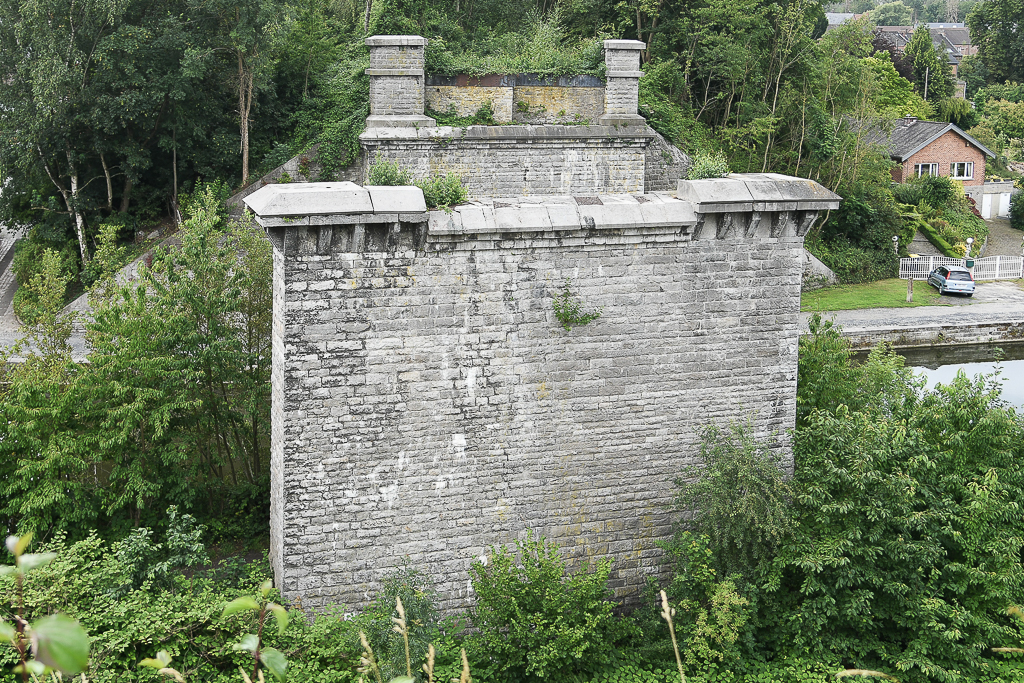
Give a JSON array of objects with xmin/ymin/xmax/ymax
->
[{"xmin": 82, "ymin": 186, "xmax": 271, "ymax": 517}]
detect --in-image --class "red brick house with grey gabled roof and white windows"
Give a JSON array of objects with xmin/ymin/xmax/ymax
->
[{"xmin": 869, "ymin": 117, "xmax": 995, "ymax": 187}]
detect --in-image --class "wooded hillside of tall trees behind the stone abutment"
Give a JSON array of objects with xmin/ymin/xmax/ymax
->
[{"xmin": 0, "ymin": 0, "xmax": 1024, "ymax": 299}]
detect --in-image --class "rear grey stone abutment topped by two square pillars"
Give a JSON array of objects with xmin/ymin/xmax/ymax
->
[{"xmin": 362, "ymin": 36, "xmax": 689, "ymax": 198}]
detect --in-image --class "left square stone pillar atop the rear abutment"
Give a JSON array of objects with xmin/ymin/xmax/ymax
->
[{"xmin": 367, "ymin": 36, "xmax": 436, "ymax": 128}]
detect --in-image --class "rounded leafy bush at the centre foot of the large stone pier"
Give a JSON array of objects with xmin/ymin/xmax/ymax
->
[{"xmin": 470, "ymin": 537, "xmax": 630, "ymax": 681}]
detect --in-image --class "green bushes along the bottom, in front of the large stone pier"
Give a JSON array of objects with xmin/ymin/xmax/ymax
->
[{"xmin": 6, "ymin": 313, "xmax": 1024, "ymax": 683}]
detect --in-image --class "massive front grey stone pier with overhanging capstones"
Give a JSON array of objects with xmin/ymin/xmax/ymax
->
[{"xmin": 246, "ymin": 175, "xmax": 839, "ymax": 610}]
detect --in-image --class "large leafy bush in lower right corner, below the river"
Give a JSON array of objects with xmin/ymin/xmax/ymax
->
[{"xmin": 766, "ymin": 373, "xmax": 1024, "ymax": 681}]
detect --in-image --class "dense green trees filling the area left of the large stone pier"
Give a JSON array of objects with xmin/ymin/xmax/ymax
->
[{"xmin": 0, "ymin": 187, "xmax": 270, "ymax": 538}]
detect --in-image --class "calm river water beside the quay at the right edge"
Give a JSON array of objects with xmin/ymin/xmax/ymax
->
[{"xmin": 868, "ymin": 342, "xmax": 1024, "ymax": 408}]
